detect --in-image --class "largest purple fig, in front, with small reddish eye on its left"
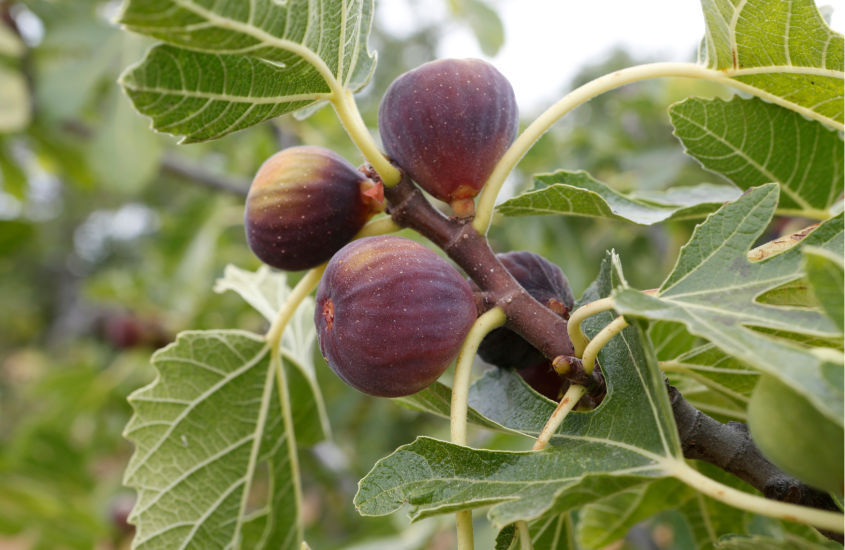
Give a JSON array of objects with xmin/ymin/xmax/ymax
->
[{"xmin": 314, "ymin": 236, "xmax": 476, "ymax": 397}]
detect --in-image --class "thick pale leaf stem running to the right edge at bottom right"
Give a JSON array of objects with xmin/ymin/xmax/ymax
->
[{"xmin": 671, "ymin": 460, "xmax": 845, "ymax": 533}]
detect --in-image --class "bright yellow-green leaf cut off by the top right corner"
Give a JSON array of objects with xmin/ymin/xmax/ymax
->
[{"xmin": 699, "ymin": 0, "xmax": 845, "ymax": 129}]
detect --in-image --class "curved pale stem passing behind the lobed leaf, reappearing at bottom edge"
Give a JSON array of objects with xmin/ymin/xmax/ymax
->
[{"xmin": 450, "ymin": 307, "xmax": 507, "ymax": 550}]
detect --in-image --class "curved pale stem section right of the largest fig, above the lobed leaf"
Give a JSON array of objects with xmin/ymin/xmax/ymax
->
[{"xmin": 450, "ymin": 307, "xmax": 507, "ymax": 445}]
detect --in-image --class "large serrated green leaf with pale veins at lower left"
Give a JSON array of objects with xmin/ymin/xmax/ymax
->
[{"xmin": 124, "ymin": 330, "xmax": 302, "ymax": 550}]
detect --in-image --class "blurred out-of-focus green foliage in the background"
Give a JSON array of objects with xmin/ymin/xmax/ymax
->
[{"xmin": 0, "ymin": 0, "xmax": 796, "ymax": 549}]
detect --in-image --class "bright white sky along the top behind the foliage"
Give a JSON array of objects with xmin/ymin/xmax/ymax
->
[{"xmin": 376, "ymin": 0, "xmax": 845, "ymax": 113}]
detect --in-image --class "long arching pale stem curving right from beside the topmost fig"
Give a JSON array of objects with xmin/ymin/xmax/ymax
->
[{"xmin": 473, "ymin": 63, "xmax": 845, "ymax": 235}]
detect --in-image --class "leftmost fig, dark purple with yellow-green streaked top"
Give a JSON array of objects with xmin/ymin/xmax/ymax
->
[{"xmin": 244, "ymin": 146, "xmax": 383, "ymax": 271}]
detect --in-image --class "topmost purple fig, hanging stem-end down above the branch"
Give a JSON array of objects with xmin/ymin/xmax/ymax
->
[{"xmin": 379, "ymin": 59, "xmax": 519, "ymax": 217}]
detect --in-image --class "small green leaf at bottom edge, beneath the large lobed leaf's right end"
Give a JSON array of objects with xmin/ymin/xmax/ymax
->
[{"xmin": 578, "ymin": 478, "xmax": 695, "ymax": 548}]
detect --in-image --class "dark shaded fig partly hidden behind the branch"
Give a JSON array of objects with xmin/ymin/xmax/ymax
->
[{"xmin": 472, "ymin": 251, "xmax": 575, "ymax": 369}]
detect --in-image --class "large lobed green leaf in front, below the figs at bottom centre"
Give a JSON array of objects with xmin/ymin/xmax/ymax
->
[{"xmin": 355, "ymin": 256, "xmax": 681, "ymax": 529}]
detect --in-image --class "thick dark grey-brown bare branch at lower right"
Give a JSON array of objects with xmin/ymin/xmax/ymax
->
[{"xmin": 667, "ymin": 384, "xmax": 843, "ymax": 544}]
